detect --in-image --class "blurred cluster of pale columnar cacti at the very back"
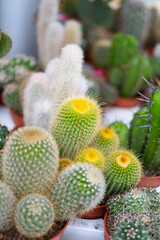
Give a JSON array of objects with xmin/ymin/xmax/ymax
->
[{"xmin": 37, "ymin": 0, "xmax": 82, "ymax": 68}]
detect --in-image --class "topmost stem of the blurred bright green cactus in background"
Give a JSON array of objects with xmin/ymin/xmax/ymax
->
[{"xmin": 109, "ymin": 33, "xmax": 138, "ymax": 68}]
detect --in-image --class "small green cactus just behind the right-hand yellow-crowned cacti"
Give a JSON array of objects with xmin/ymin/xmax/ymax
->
[{"xmin": 109, "ymin": 121, "xmax": 129, "ymax": 148}]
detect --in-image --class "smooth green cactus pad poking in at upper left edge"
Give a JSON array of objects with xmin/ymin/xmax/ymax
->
[{"xmin": 0, "ymin": 29, "xmax": 12, "ymax": 58}]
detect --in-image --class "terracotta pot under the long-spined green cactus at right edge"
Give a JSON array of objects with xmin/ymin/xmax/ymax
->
[{"xmin": 137, "ymin": 176, "xmax": 160, "ymax": 188}]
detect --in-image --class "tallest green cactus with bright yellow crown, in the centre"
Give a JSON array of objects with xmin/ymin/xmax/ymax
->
[{"xmin": 51, "ymin": 97, "xmax": 101, "ymax": 158}]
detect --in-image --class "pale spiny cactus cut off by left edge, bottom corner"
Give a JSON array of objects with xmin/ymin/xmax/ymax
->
[{"xmin": 0, "ymin": 181, "xmax": 16, "ymax": 232}]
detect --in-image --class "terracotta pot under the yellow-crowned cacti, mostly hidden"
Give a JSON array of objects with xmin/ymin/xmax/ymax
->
[{"xmin": 81, "ymin": 205, "xmax": 106, "ymax": 219}]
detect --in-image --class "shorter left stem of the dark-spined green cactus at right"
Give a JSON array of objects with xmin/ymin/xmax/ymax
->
[{"xmin": 130, "ymin": 106, "xmax": 149, "ymax": 155}]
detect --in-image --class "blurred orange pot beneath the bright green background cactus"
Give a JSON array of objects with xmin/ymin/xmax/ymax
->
[{"xmin": 113, "ymin": 97, "xmax": 141, "ymax": 108}]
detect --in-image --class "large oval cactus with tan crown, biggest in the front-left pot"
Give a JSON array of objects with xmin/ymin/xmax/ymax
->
[{"xmin": 2, "ymin": 126, "xmax": 59, "ymax": 197}]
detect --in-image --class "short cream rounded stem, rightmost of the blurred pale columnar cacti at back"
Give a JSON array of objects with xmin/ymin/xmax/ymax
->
[{"xmin": 63, "ymin": 20, "xmax": 82, "ymax": 46}]
